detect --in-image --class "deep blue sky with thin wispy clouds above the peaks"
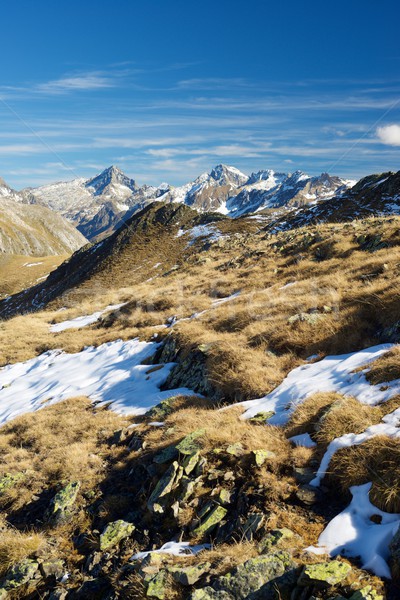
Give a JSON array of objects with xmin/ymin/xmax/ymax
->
[{"xmin": 0, "ymin": 0, "xmax": 400, "ymax": 189}]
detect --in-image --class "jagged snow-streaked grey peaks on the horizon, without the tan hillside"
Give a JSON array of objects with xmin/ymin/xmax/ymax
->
[{"xmin": 3, "ymin": 164, "xmax": 355, "ymax": 240}]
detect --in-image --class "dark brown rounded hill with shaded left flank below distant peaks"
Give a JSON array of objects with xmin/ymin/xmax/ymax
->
[{"xmin": 0, "ymin": 202, "xmax": 253, "ymax": 317}]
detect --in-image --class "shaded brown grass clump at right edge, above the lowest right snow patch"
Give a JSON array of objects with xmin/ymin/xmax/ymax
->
[{"xmin": 329, "ymin": 436, "xmax": 400, "ymax": 513}]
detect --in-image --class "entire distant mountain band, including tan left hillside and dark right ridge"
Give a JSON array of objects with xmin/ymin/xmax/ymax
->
[{"xmin": 0, "ymin": 165, "xmax": 400, "ymax": 256}]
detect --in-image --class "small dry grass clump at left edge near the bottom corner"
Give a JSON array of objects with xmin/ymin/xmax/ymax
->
[{"xmin": 0, "ymin": 529, "xmax": 47, "ymax": 576}]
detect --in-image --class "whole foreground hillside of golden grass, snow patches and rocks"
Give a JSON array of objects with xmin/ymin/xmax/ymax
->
[{"xmin": 0, "ymin": 192, "xmax": 400, "ymax": 600}]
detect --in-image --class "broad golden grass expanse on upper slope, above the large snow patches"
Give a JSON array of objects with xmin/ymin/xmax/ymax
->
[{"xmin": 0, "ymin": 218, "xmax": 400, "ymax": 402}]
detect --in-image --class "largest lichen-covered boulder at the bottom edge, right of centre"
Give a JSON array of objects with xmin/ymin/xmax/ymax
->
[{"xmin": 212, "ymin": 552, "xmax": 296, "ymax": 600}]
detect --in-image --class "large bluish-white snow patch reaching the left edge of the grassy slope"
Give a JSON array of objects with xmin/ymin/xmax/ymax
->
[{"xmin": 0, "ymin": 339, "xmax": 193, "ymax": 425}]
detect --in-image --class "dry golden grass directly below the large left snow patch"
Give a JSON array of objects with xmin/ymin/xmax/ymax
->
[{"xmin": 0, "ymin": 398, "xmax": 128, "ymax": 510}]
